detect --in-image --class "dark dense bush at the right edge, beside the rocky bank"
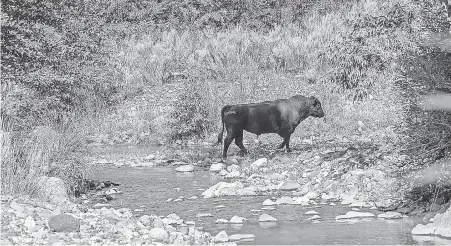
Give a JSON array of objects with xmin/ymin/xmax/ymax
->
[{"xmin": 397, "ymin": 50, "xmax": 451, "ymax": 166}]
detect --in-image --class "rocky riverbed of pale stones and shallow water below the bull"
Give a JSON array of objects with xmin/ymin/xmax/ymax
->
[{"xmin": 1, "ymin": 140, "xmax": 451, "ymax": 245}]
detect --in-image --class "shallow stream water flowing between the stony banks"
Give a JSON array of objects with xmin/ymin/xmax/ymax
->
[{"xmin": 93, "ymin": 165, "xmax": 451, "ymax": 245}]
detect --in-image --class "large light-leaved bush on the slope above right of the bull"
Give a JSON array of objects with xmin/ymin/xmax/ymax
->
[{"xmin": 319, "ymin": 1, "xmax": 432, "ymax": 100}]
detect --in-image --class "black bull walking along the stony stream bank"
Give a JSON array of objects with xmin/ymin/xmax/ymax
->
[{"xmin": 218, "ymin": 95, "xmax": 324, "ymax": 158}]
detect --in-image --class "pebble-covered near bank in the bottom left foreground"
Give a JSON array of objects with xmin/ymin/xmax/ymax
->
[{"xmin": 0, "ymin": 197, "xmax": 218, "ymax": 245}]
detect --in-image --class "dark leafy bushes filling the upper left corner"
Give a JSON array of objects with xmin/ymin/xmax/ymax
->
[{"xmin": 1, "ymin": 1, "xmax": 120, "ymax": 133}]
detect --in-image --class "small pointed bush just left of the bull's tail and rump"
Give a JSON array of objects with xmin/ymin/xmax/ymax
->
[{"xmin": 170, "ymin": 82, "xmax": 213, "ymax": 140}]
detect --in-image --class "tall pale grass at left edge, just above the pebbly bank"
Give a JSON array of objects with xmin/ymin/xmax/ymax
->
[{"xmin": 1, "ymin": 108, "xmax": 91, "ymax": 196}]
